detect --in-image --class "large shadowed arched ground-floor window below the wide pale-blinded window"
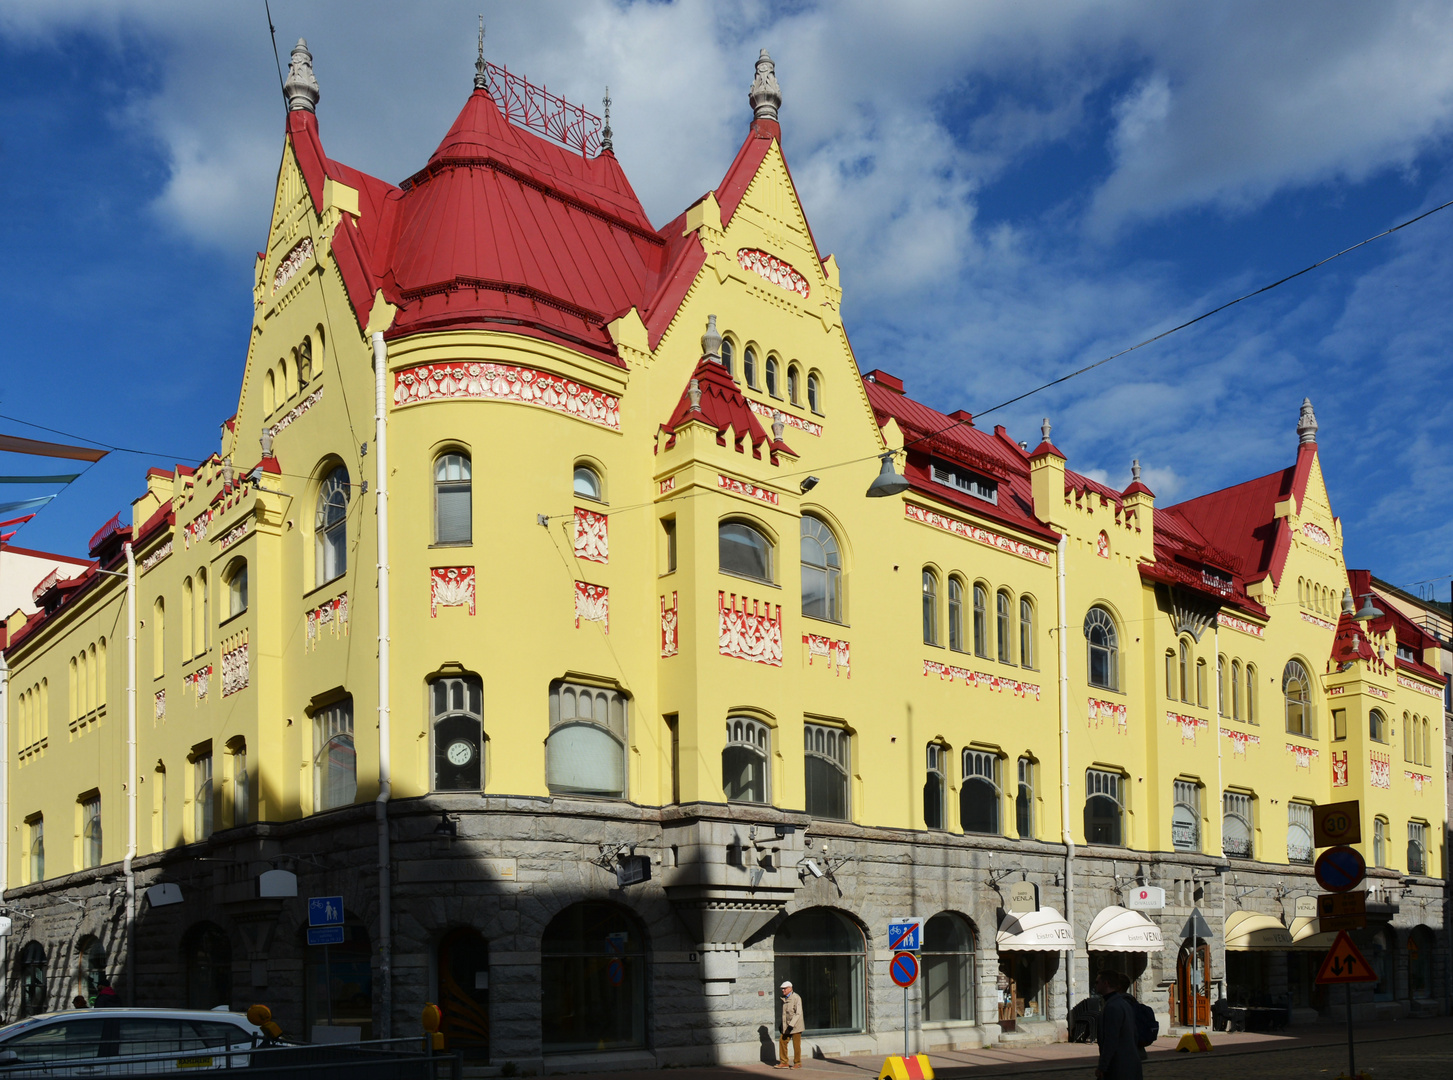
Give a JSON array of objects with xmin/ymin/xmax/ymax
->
[{"xmin": 541, "ymin": 903, "xmax": 647, "ymax": 1054}]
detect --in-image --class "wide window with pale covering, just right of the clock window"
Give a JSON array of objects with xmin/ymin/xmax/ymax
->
[{"xmin": 545, "ymin": 682, "xmax": 628, "ymax": 798}]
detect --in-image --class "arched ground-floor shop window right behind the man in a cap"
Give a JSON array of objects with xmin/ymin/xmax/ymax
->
[{"xmin": 772, "ymin": 907, "xmax": 867, "ymax": 1035}]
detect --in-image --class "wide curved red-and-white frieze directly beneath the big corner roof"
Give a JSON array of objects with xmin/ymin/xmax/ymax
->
[{"xmin": 394, "ymin": 362, "xmax": 620, "ymax": 432}]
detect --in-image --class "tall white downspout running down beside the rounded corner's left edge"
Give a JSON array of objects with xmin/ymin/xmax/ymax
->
[{"xmin": 373, "ymin": 330, "xmax": 394, "ymax": 1039}]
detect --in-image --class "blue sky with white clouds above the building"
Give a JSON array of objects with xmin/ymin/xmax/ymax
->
[{"xmin": 0, "ymin": 0, "xmax": 1453, "ymax": 599}]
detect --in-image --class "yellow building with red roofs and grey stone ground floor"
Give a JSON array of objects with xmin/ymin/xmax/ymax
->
[{"xmin": 4, "ymin": 42, "xmax": 1447, "ymax": 1068}]
